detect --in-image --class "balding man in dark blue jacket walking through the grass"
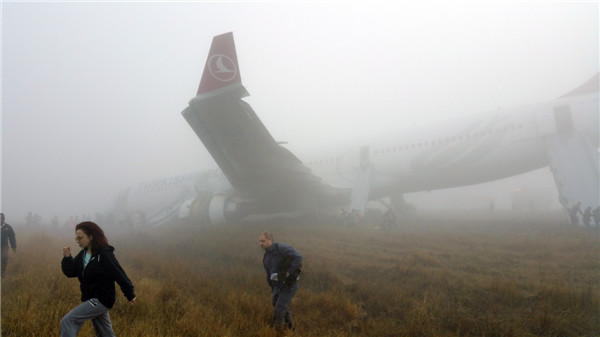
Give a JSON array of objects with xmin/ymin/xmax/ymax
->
[{"xmin": 258, "ymin": 232, "xmax": 302, "ymax": 331}]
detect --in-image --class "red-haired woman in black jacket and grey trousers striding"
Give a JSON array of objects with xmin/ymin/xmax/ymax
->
[{"xmin": 60, "ymin": 221, "xmax": 136, "ymax": 337}]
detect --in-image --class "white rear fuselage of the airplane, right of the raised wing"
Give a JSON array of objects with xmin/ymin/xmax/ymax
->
[{"xmin": 306, "ymin": 93, "xmax": 598, "ymax": 198}]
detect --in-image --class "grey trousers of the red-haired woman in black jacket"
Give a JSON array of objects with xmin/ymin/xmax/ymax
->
[{"xmin": 60, "ymin": 298, "xmax": 115, "ymax": 337}]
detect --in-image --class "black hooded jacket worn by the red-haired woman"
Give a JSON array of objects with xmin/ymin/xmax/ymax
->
[{"xmin": 61, "ymin": 246, "xmax": 135, "ymax": 309}]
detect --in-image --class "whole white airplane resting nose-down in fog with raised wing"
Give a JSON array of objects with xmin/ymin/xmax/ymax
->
[{"xmin": 117, "ymin": 32, "xmax": 600, "ymax": 225}]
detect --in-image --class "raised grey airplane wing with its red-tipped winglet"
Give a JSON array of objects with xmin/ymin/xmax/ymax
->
[{"xmin": 182, "ymin": 33, "xmax": 338, "ymax": 211}]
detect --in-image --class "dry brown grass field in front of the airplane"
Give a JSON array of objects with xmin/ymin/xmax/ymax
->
[{"xmin": 1, "ymin": 211, "xmax": 600, "ymax": 337}]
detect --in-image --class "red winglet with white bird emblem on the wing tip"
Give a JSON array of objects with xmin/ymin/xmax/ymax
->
[{"xmin": 197, "ymin": 32, "xmax": 242, "ymax": 95}]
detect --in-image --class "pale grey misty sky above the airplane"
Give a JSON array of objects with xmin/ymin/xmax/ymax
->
[{"xmin": 1, "ymin": 1, "xmax": 600, "ymax": 222}]
